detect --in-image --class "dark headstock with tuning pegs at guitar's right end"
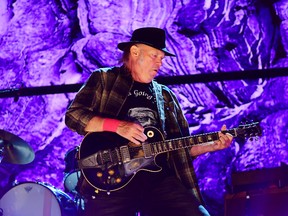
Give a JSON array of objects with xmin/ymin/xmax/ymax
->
[{"xmin": 235, "ymin": 122, "xmax": 262, "ymax": 139}]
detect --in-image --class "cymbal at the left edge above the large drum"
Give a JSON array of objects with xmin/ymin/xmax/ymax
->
[{"xmin": 0, "ymin": 130, "xmax": 35, "ymax": 164}]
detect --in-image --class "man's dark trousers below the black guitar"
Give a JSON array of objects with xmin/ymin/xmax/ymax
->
[{"xmin": 80, "ymin": 172, "xmax": 209, "ymax": 216}]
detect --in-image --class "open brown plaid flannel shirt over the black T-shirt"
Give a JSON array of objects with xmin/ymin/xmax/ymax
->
[{"xmin": 65, "ymin": 66, "xmax": 203, "ymax": 203}]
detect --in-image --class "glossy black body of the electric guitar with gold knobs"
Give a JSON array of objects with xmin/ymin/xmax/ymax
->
[{"xmin": 78, "ymin": 127, "xmax": 163, "ymax": 192}]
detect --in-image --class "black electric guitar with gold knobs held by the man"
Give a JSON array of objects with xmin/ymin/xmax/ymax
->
[{"xmin": 78, "ymin": 123, "xmax": 261, "ymax": 194}]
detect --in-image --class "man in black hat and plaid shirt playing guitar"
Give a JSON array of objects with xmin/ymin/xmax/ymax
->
[{"xmin": 66, "ymin": 27, "xmax": 232, "ymax": 216}]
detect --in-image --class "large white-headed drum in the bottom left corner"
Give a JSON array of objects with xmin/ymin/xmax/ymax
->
[{"xmin": 0, "ymin": 182, "xmax": 77, "ymax": 216}]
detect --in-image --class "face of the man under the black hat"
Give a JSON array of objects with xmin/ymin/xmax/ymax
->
[{"xmin": 130, "ymin": 44, "xmax": 165, "ymax": 83}]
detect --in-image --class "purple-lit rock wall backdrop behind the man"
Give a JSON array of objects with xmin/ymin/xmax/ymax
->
[{"xmin": 0, "ymin": 0, "xmax": 288, "ymax": 216}]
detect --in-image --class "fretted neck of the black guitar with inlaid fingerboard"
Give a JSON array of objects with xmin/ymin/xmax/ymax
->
[{"xmin": 142, "ymin": 129, "xmax": 237, "ymax": 157}]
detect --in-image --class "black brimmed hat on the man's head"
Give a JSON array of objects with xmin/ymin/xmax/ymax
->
[{"xmin": 117, "ymin": 27, "xmax": 175, "ymax": 56}]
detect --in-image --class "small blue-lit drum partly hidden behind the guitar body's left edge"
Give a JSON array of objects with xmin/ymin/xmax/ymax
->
[{"xmin": 64, "ymin": 146, "xmax": 81, "ymax": 193}]
